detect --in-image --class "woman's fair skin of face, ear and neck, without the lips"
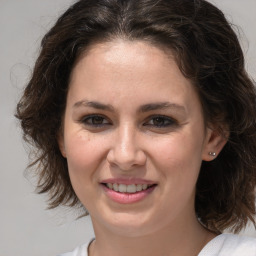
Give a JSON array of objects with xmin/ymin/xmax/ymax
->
[{"xmin": 59, "ymin": 40, "xmax": 226, "ymax": 256}]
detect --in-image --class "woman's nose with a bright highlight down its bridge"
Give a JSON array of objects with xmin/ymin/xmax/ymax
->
[{"xmin": 107, "ymin": 125, "xmax": 147, "ymax": 171}]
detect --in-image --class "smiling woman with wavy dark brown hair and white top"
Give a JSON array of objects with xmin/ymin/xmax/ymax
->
[{"xmin": 17, "ymin": 0, "xmax": 256, "ymax": 256}]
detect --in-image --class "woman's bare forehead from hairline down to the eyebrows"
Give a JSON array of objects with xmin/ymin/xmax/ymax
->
[{"xmin": 67, "ymin": 39, "xmax": 202, "ymax": 114}]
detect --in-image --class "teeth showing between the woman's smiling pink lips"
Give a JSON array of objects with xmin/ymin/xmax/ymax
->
[{"xmin": 102, "ymin": 183, "xmax": 156, "ymax": 194}]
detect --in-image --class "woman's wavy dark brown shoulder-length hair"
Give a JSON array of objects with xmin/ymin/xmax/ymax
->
[{"xmin": 16, "ymin": 0, "xmax": 256, "ymax": 232}]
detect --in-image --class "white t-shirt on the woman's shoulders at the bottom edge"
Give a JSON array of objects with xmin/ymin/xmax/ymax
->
[{"xmin": 59, "ymin": 234, "xmax": 256, "ymax": 256}]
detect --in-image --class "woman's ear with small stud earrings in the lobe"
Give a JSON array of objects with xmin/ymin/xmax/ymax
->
[{"xmin": 202, "ymin": 128, "xmax": 229, "ymax": 161}]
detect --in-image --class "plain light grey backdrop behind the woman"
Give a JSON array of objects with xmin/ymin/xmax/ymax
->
[{"xmin": 0, "ymin": 0, "xmax": 256, "ymax": 256}]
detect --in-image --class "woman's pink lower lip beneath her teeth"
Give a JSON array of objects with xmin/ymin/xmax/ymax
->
[{"xmin": 101, "ymin": 184, "xmax": 156, "ymax": 204}]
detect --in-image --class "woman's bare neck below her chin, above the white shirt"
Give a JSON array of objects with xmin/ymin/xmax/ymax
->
[{"xmin": 89, "ymin": 218, "xmax": 216, "ymax": 256}]
